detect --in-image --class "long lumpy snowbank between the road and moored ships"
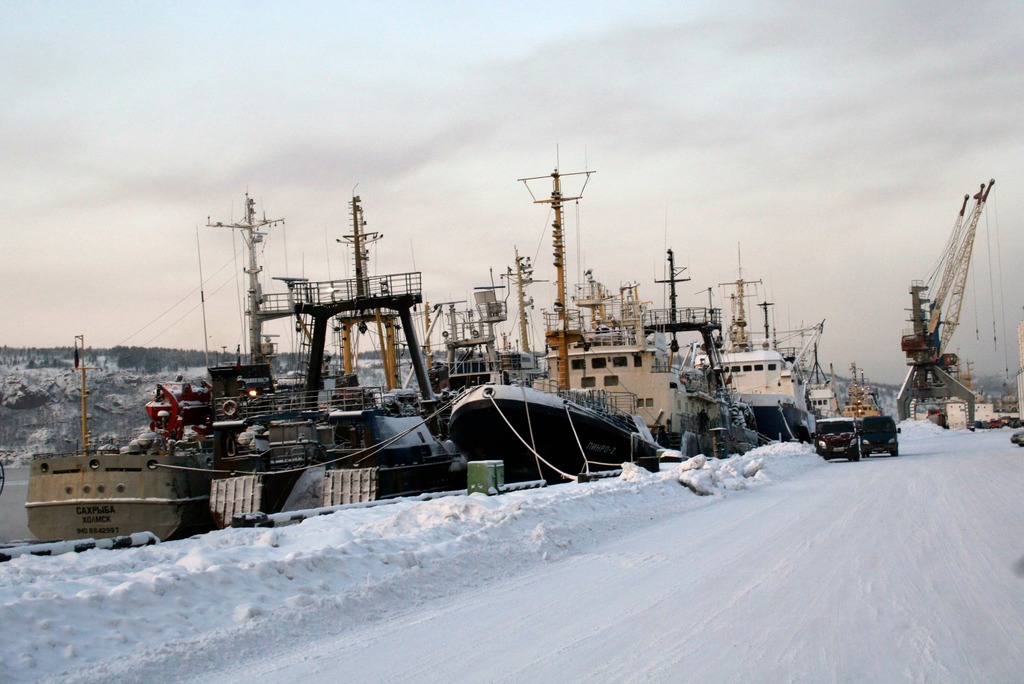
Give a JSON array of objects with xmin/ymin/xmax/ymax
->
[{"xmin": 0, "ymin": 444, "xmax": 821, "ymax": 681}]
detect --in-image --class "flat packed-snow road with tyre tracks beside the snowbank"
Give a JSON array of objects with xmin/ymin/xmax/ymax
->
[{"xmin": 209, "ymin": 433, "xmax": 1024, "ymax": 682}]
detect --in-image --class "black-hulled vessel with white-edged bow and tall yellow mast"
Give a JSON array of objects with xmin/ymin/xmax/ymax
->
[{"xmin": 450, "ymin": 169, "xmax": 658, "ymax": 483}]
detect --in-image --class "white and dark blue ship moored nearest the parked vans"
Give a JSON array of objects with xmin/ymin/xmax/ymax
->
[{"xmin": 721, "ymin": 269, "xmax": 824, "ymax": 442}]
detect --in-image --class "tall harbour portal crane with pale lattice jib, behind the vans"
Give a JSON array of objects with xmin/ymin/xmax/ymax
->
[{"xmin": 896, "ymin": 179, "xmax": 995, "ymax": 425}]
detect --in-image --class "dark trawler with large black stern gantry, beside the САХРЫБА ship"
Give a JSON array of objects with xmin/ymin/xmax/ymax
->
[{"xmin": 204, "ymin": 196, "xmax": 465, "ymax": 527}]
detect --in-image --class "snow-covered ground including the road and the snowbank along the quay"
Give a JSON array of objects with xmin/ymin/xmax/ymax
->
[{"xmin": 0, "ymin": 423, "xmax": 1024, "ymax": 682}]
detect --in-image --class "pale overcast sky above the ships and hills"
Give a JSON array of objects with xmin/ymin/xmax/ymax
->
[{"xmin": 0, "ymin": 0, "xmax": 1024, "ymax": 383}]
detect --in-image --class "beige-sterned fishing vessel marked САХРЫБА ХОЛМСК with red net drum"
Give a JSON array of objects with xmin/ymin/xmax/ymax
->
[{"xmin": 26, "ymin": 195, "xmax": 292, "ymax": 540}]
